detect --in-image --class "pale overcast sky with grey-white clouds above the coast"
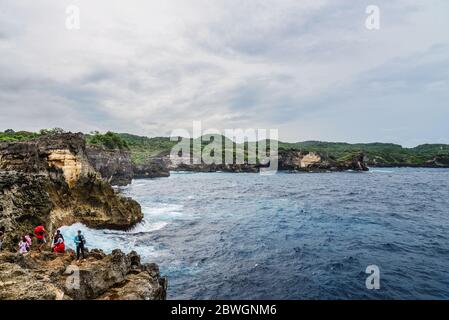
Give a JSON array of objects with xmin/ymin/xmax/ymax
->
[{"xmin": 0, "ymin": 0, "xmax": 449, "ymax": 147}]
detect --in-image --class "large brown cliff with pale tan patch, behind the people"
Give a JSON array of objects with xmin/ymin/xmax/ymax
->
[{"xmin": 0, "ymin": 133, "xmax": 143, "ymax": 247}]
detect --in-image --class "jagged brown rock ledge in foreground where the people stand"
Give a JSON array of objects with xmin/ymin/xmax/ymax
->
[{"xmin": 0, "ymin": 250, "xmax": 167, "ymax": 300}]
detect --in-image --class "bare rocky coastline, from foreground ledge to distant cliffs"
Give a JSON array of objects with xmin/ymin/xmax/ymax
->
[{"xmin": 0, "ymin": 133, "xmax": 442, "ymax": 299}]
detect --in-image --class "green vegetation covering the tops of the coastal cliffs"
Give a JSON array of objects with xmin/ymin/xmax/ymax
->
[{"xmin": 0, "ymin": 129, "xmax": 449, "ymax": 166}]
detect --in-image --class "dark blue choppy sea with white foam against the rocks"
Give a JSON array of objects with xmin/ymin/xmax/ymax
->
[{"xmin": 64, "ymin": 169, "xmax": 449, "ymax": 299}]
